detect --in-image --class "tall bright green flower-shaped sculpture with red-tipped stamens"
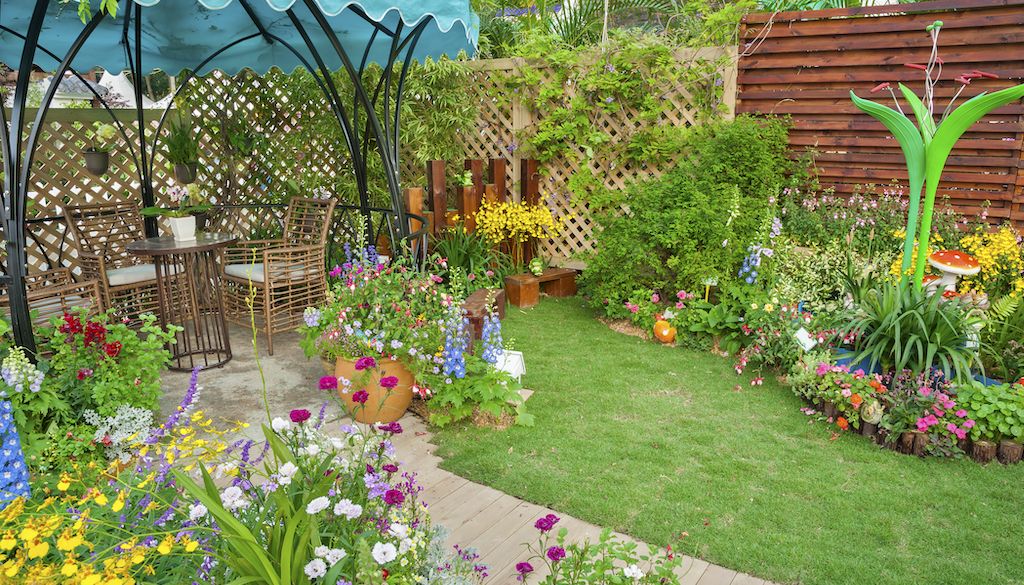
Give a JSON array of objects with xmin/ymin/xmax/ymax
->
[{"xmin": 850, "ymin": 22, "xmax": 1024, "ymax": 287}]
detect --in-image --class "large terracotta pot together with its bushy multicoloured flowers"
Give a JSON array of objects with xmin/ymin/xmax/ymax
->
[{"xmin": 300, "ymin": 240, "xmax": 458, "ymax": 422}]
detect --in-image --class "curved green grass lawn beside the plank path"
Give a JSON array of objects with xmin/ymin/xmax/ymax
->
[{"xmin": 436, "ymin": 298, "xmax": 1024, "ymax": 585}]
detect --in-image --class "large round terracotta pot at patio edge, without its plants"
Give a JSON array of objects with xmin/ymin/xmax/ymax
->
[{"xmin": 334, "ymin": 358, "xmax": 414, "ymax": 423}]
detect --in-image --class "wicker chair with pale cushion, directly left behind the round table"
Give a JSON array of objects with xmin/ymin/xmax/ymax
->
[{"xmin": 65, "ymin": 203, "xmax": 159, "ymax": 319}]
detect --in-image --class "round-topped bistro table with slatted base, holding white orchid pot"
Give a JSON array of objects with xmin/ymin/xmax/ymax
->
[{"xmin": 128, "ymin": 233, "xmax": 239, "ymax": 371}]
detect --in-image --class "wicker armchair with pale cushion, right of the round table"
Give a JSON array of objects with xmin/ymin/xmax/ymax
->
[{"xmin": 223, "ymin": 197, "xmax": 335, "ymax": 354}]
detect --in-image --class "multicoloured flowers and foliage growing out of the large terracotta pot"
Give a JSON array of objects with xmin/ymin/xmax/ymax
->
[{"xmin": 300, "ymin": 247, "xmax": 461, "ymax": 373}]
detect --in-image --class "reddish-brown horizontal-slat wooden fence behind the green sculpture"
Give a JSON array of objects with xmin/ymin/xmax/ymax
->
[{"xmin": 736, "ymin": 0, "xmax": 1024, "ymax": 225}]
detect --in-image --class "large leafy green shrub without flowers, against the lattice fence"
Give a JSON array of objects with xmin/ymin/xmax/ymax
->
[{"xmin": 580, "ymin": 116, "xmax": 794, "ymax": 317}]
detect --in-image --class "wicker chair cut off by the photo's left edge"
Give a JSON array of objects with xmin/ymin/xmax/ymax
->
[{"xmin": 0, "ymin": 268, "xmax": 103, "ymax": 326}]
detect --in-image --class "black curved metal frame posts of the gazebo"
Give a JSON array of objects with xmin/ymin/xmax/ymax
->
[{"xmin": 0, "ymin": 0, "xmax": 448, "ymax": 351}]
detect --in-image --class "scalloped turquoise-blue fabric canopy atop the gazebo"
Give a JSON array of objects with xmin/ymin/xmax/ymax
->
[{"xmin": 0, "ymin": 0, "xmax": 479, "ymax": 75}]
